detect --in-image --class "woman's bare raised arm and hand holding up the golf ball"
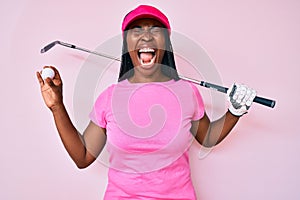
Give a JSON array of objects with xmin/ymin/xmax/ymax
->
[{"xmin": 37, "ymin": 67, "xmax": 106, "ymax": 168}]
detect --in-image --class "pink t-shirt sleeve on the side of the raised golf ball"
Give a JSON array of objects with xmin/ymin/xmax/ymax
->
[{"xmin": 89, "ymin": 86, "xmax": 112, "ymax": 128}]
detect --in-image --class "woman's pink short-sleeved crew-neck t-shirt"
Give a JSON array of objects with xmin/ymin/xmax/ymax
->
[{"xmin": 90, "ymin": 80, "xmax": 204, "ymax": 200}]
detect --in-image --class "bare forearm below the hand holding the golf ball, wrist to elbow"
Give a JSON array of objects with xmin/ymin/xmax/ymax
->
[{"xmin": 52, "ymin": 104, "xmax": 87, "ymax": 168}]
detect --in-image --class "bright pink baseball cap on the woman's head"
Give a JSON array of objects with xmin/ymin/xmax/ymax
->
[{"xmin": 122, "ymin": 5, "xmax": 171, "ymax": 33}]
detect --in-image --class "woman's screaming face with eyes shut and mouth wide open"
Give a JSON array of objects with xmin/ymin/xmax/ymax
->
[{"xmin": 126, "ymin": 19, "xmax": 165, "ymax": 76}]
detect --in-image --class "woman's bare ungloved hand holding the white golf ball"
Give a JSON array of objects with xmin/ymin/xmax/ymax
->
[{"xmin": 36, "ymin": 66, "xmax": 63, "ymax": 111}]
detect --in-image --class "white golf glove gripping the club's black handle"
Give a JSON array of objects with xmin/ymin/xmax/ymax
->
[{"xmin": 227, "ymin": 83, "xmax": 256, "ymax": 117}]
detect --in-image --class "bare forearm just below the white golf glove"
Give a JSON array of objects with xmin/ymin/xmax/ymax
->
[{"xmin": 204, "ymin": 111, "xmax": 239, "ymax": 147}]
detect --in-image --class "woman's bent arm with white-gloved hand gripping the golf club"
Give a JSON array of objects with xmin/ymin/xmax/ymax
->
[{"xmin": 191, "ymin": 84, "xmax": 256, "ymax": 147}]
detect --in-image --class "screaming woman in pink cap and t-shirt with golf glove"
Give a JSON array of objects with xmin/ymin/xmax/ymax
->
[{"xmin": 37, "ymin": 5, "xmax": 255, "ymax": 200}]
